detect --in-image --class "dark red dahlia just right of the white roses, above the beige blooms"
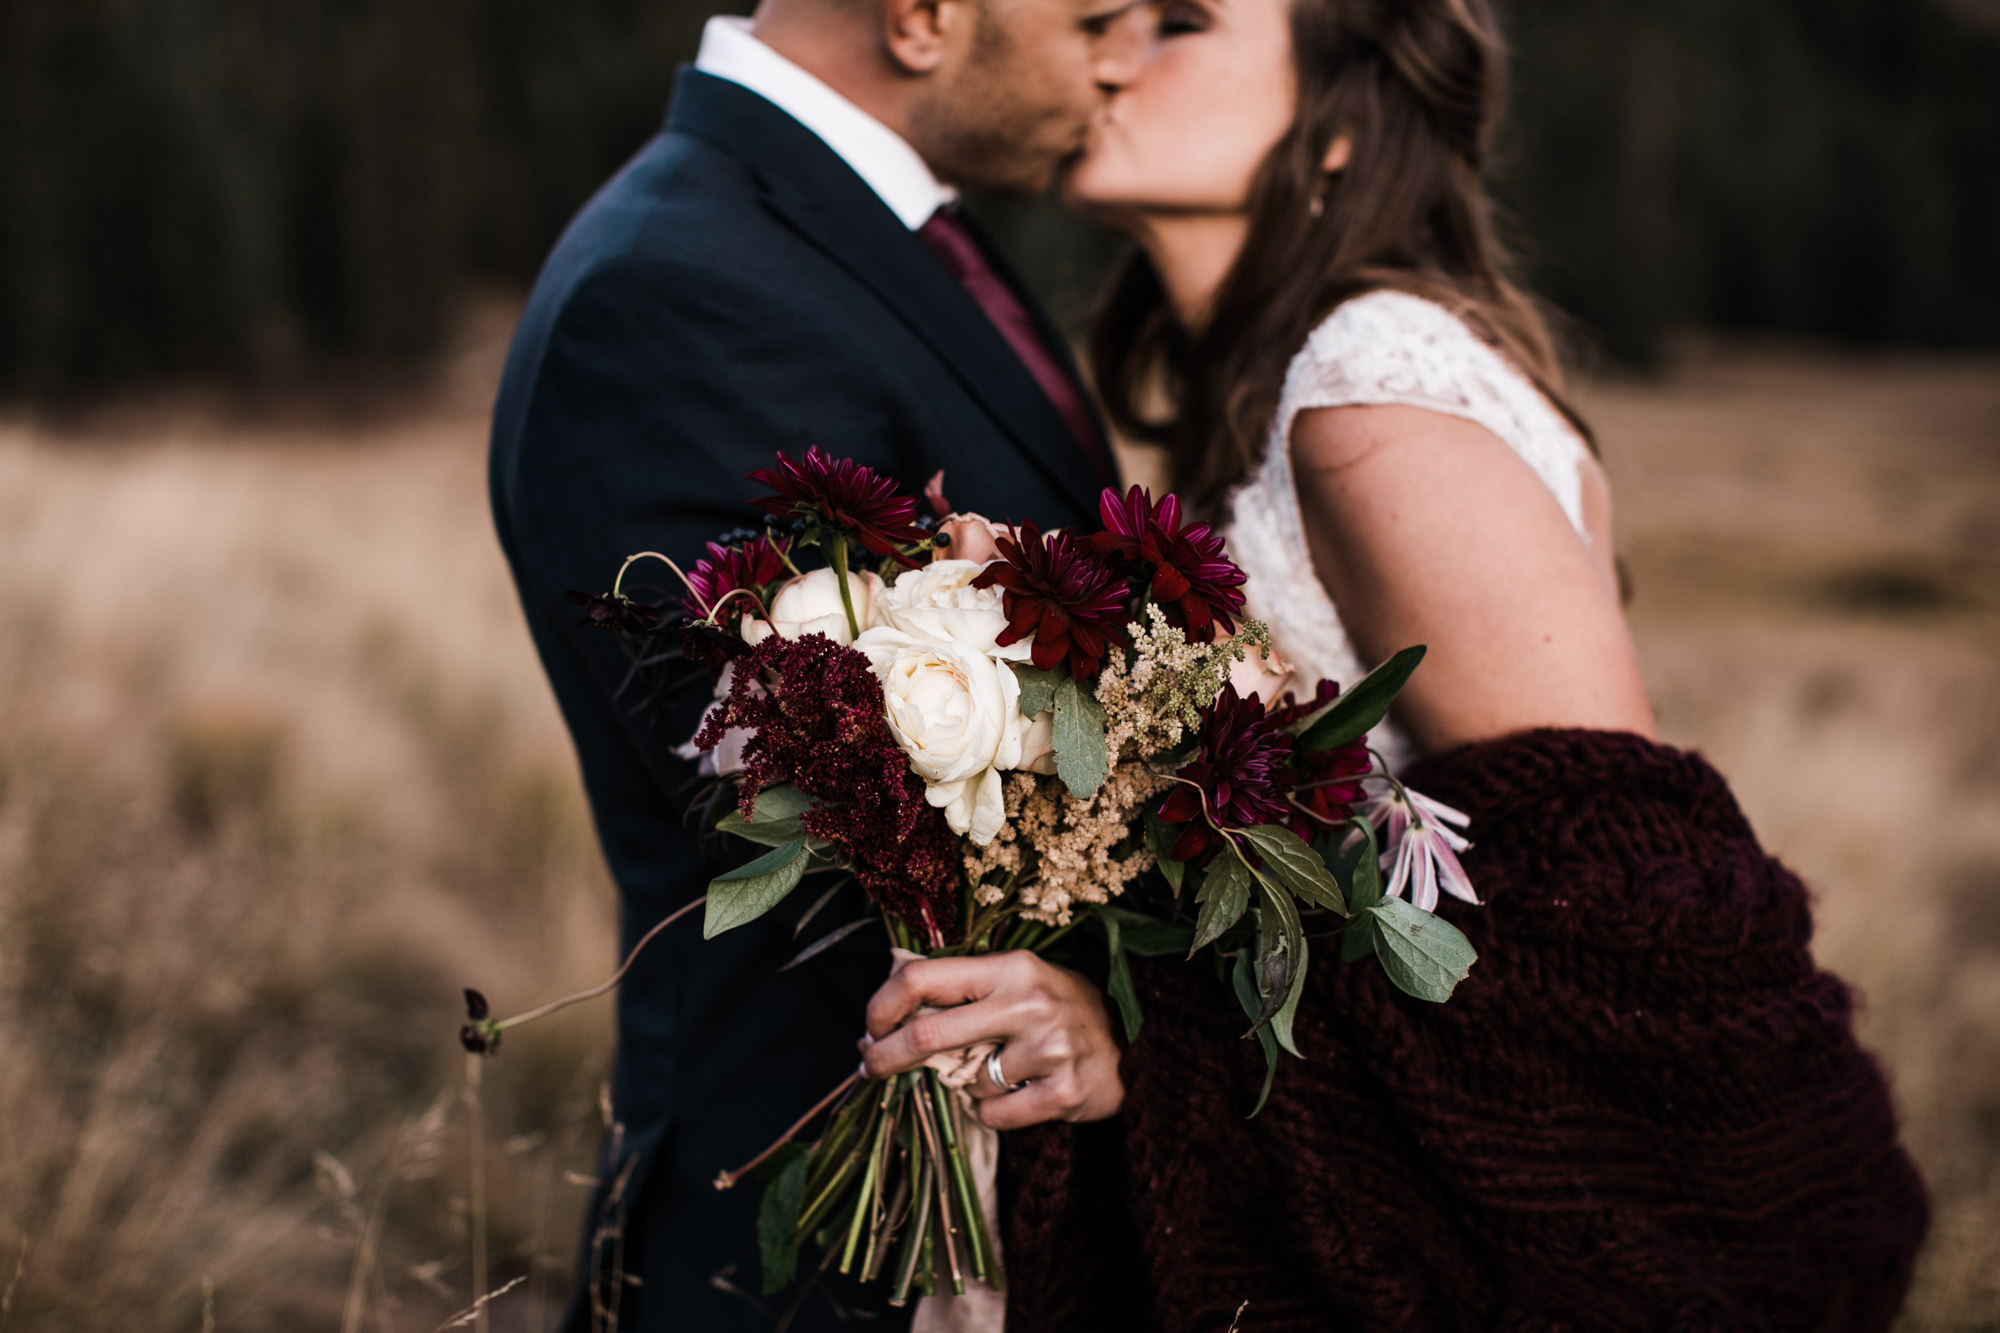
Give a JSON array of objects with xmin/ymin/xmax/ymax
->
[{"xmin": 972, "ymin": 522, "xmax": 1132, "ymax": 681}]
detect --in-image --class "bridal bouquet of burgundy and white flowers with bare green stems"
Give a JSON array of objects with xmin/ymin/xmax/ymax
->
[{"xmin": 476, "ymin": 448, "xmax": 1476, "ymax": 1305}]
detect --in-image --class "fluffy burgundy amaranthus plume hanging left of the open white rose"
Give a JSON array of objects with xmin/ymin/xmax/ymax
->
[{"xmin": 694, "ymin": 634, "xmax": 960, "ymax": 932}]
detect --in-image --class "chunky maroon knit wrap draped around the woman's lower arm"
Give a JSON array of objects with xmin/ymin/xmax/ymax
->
[{"xmin": 1002, "ymin": 731, "xmax": 1928, "ymax": 1333}]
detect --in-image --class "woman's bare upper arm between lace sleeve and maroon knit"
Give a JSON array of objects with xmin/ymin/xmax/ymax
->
[{"xmin": 1292, "ymin": 406, "xmax": 1654, "ymax": 753}]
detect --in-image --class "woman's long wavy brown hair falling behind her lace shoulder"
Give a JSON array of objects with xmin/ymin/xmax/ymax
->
[{"xmin": 1090, "ymin": 0, "xmax": 1592, "ymax": 516}]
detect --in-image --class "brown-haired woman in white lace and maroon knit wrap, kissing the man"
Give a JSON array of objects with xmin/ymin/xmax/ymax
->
[{"xmin": 868, "ymin": 0, "xmax": 1926, "ymax": 1333}]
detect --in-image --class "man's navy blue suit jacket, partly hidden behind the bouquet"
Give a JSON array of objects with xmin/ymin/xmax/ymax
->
[{"xmin": 490, "ymin": 70, "xmax": 1098, "ymax": 1333}]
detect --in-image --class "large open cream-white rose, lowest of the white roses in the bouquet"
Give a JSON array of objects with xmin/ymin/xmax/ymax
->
[{"xmin": 854, "ymin": 626, "xmax": 1026, "ymax": 847}]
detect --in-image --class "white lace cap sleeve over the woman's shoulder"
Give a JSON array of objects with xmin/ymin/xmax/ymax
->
[{"xmin": 1272, "ymin": 292, "xmax": 1590, "ymax": 542}]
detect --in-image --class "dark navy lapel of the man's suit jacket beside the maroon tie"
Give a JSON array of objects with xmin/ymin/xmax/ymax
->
[{"xmin": 668, "ymin": 70, "xmax": 1098, "ymax": 512}]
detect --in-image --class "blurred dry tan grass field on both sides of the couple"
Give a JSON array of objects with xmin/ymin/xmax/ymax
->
[{"xmin": 0, "ymin": 314, "xmax": 2000, "ymax": 1333}]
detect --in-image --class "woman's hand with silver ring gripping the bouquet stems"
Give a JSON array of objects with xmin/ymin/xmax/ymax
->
[{"xmin": 862, "ymin": 953, "xmax": 1124, "ymax": 1129}]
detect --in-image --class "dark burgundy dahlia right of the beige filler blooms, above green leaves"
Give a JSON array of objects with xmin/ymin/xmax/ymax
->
[{"xmin": 1158, "ymin": 685, "xmax": 1298, "ymax": 861}]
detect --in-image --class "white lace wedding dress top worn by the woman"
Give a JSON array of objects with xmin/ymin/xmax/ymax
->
[{"xmin": 1228, "ymin": 292, "xmax": 1590, "ymax": 769}]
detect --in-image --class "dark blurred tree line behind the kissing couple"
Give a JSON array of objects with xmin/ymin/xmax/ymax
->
[{"xmin": 0, "ymin": 0, "xmax": 2000, "ymax": 396}]
